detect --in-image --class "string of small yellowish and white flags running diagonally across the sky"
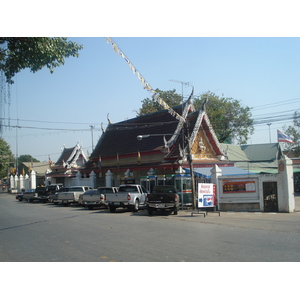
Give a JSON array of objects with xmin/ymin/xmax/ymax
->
[{"xmin": 106, "ymin": 37, "xmax": 185, "ymax": 125}]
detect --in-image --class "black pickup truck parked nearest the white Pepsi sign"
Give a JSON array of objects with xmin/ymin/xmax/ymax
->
[{"xmin": 146, "ymin": 185, "xmax": 179, "ymax": 215}]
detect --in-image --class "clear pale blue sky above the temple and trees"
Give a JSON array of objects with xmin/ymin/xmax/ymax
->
[{"xmin": 3, "ymin": 37, "xmax": 300, "ymax": 161}]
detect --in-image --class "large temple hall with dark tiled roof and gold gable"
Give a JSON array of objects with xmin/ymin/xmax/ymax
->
[{"xmin": 82, "ymin": 99, "xmax": 234, "ymax": 203}]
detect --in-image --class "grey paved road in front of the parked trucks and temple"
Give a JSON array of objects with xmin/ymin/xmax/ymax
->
[{"xmin": 0, "ymin": 193, "xmax": 300, "ymax": 262}]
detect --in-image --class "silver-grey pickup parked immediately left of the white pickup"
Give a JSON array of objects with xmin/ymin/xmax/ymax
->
[{"xmin": 79, "ymin": 187, "xmax": 118, "ymax": 209}]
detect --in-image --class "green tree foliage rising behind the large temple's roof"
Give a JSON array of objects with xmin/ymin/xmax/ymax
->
[{"xmin": 137, "ymin": 89, "xmax": 254, "ymax": 144}]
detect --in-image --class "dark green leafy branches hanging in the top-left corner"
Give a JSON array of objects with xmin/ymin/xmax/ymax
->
[{"xmin": 0, "ymin": 37, "xmax": 83, "ymax": 84}]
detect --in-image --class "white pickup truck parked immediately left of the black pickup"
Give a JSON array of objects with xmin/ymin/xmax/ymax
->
[{"xmin": 106, "ymin": 184, "xmax": 148, "ymax": 212}]
